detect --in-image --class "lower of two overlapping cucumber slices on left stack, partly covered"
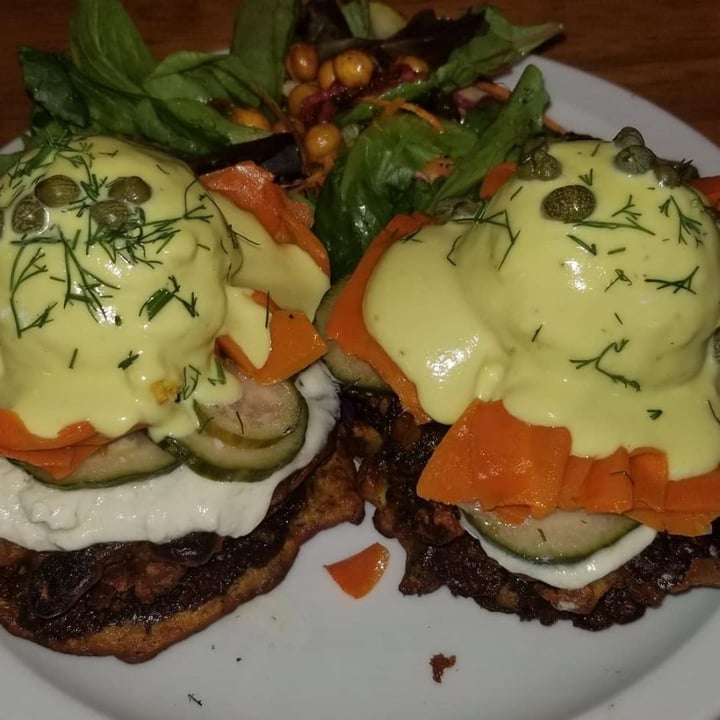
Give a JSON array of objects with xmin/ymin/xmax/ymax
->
[{"xmin": 160, "ymin": 399, "xmax": 308, "ymax": 482}]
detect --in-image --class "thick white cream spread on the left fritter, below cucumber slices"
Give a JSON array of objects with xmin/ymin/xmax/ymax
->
[{"xmin": 0, "ymin": 364, "xmax": 339, "ymax": 550}]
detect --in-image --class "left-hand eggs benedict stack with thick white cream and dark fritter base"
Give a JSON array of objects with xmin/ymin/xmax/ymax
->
[{"xmin": 0, "ymin": 137, "xmax": 362, "ymax": 662}]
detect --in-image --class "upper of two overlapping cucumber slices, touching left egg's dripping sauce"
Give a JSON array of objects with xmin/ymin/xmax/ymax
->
[{"xmin": 195, "ymin": 374, "xmax": 307, "ymax": 448}]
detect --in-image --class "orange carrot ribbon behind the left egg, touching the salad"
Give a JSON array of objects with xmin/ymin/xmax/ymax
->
[{"xmin": 200, "ymin": 162, "xmax": 330, "ymax": 275}]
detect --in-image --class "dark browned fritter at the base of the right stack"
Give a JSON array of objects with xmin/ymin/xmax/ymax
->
[{"xmin": 346, "ymin": 391, "xmax": 720, "ymax": 630}]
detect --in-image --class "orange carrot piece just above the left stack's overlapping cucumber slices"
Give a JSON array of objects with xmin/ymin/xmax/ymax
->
[{"xmin": 217, "ymin": 292, "xmax": 327, "ymax": 385}]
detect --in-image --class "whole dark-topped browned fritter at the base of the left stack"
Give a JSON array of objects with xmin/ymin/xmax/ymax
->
[{"xmin": 0, "ymin": 449, "xmax": 364, "ymax": 663}]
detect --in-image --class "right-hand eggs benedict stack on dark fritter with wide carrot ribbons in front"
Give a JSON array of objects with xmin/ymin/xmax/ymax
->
[{"xmin": 328, "ymin": 128, "xmax": 720, "ymax": 629}]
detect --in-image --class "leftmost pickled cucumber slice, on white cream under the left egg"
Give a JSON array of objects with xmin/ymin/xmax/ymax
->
[{"xmin": 16, "ymin": 430, "xmax": 180, "ymax": 490}]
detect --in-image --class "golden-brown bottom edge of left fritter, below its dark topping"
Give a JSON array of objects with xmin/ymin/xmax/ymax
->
[{"xmin": 0, "ymin": 451, "xmax": 364, "ymax": 663}]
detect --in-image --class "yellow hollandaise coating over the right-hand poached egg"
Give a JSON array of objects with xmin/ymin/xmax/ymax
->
[{"xmin": 363, "ymin": 141, "xmax": 720, "ymax": 479}]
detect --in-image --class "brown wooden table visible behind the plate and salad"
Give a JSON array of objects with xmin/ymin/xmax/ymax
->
[{"xmin": 0, "ymin": 0, "xmax": 720, "ymax": 150}]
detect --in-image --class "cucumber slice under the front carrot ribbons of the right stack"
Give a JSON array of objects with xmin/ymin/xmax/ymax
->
[{"xmin": 460, "ymin": 505, "xmax": 638, "ymax": 564}]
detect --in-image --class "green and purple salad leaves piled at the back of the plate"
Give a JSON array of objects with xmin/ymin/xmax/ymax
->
[{"xmin": 9, "ymin": 0, "xmax": 561, "ymax": 277}]
